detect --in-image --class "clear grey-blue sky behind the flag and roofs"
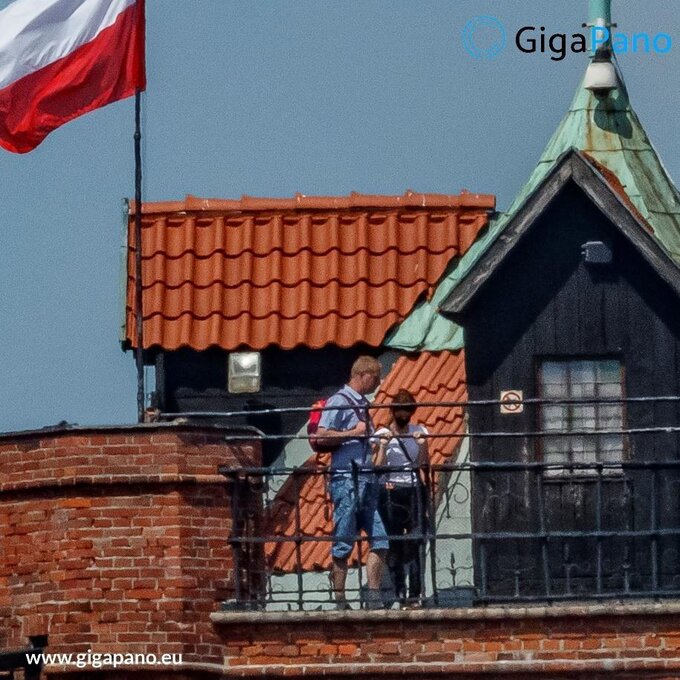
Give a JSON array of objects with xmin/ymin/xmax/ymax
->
[{"xmin": 0, "ymin": 0, "xmax": 680, "ymax": 431}]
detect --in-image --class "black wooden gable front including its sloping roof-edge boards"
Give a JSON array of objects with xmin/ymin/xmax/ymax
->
[{"xmin": 446, "ymin": 147, "xmax": 680, "ymax": 597}]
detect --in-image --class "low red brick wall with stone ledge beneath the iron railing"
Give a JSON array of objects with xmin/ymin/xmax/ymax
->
[{"xmin": 212, "ymin": 602, "xmax": 680, "ymax": 680}]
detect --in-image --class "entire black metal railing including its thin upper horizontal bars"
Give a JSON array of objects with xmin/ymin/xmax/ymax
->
[{"xmin": 162, "ymin": 395, "xmax": 680, "ymax": 610}]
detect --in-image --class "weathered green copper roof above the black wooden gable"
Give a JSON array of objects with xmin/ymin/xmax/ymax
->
[{"xmin": 386, "ymin": 62, "xmax": 680, "ymax": 351}]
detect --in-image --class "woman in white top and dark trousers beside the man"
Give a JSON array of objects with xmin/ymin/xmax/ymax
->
[{"xmin": 375, "ymin": 390, "xmax": 429, "ymax": 607}]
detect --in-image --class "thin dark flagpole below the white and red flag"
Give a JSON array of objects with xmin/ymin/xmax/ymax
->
[{"xmin": 134, "ymin": 90, "xmax": 144, "ymax": 423}]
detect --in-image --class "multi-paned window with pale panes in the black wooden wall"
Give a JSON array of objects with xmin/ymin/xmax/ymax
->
[{"xmin": 538, "ymin": 359, "xmax": 624, "ymax": 464}]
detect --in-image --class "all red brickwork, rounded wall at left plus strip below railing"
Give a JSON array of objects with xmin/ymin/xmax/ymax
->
[{"xmin": 0, "ymin": 425, "xmax": 680, "ymax": 680}]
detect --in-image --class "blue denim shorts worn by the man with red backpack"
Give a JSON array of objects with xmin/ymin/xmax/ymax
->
[{"xmin": 330, "ymin": 474, "xmax": 389, "ymax": 559}]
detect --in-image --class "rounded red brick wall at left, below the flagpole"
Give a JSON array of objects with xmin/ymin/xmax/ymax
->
[{"xmin": 0, "ymin": 425, "xmax": 260, "ymax": 676}]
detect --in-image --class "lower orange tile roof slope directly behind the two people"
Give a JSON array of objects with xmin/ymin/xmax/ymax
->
[{"xmin": 265, "ymin": 350, "xmax": 467, "ymax": 573}]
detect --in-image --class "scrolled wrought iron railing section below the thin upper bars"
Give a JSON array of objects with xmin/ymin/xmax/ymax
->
[{"xmin": 220, "ymin": 456, "xmax": 680, "ymax": 609}]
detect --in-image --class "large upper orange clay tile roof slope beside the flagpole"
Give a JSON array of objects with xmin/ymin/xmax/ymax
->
[{"xmin": 125, "ymin": 192, "xmax": 494, "ymax": 350}]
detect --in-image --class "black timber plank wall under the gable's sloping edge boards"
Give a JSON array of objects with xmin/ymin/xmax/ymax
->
[{"xmin": 463, "ymin": 181, "xmax": 680, "ymax": 594}]
